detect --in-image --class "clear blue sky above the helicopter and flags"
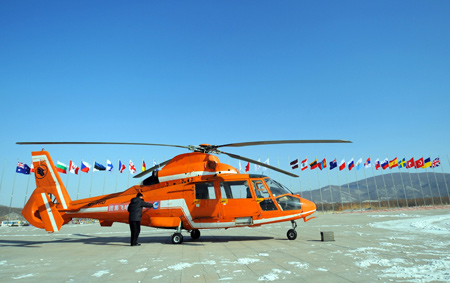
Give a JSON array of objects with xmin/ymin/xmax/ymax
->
[{"xmin": 0, "ymin": 1, "xmax": 450, "ymax": 206}]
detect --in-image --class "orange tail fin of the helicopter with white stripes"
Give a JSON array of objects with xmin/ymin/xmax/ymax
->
[{"xmin": 22, "ymin": 151, "xmax": 72, "ymax": 232}]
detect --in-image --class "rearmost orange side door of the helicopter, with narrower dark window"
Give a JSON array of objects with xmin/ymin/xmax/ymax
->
[{"xmin": 192, "ymin": 182, "xmax": 220, "ymax": 220}]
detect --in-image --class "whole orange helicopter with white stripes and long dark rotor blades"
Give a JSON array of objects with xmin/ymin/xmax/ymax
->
[{"xmin": 17, "ymin": 140, "xmax": 351, "ymax": 244}]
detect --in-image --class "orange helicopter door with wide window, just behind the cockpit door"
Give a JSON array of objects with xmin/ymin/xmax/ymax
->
[{"xmin": 220, "ymin": 181, "xmax": 258, "ymax": 225}]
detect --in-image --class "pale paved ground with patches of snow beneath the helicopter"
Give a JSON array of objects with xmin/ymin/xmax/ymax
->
[{"xmin": 0, "ymin": 209, "xmax": 450, "ymax": 282}]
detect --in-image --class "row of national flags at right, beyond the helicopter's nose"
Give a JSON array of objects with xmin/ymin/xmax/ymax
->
[{"xmin": 290, "ymin": 157, "xmax": 441, "ymax": 171}]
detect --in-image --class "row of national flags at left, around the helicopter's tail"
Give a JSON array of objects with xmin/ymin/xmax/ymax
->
[{"xmin": 16, "ymin": 159, "xmax": 149, "ymax": 175}]
